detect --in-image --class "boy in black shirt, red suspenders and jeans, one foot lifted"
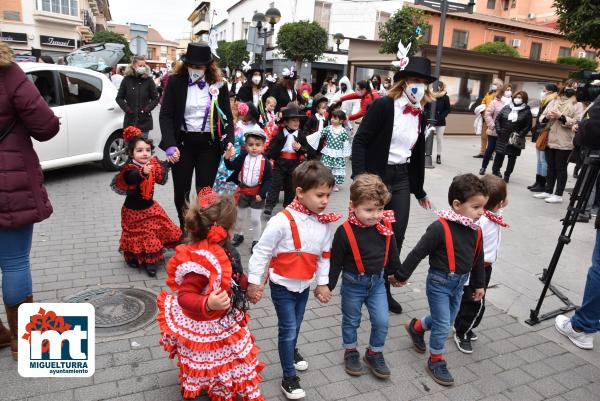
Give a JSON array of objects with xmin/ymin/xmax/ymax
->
[{"xmin": 389, "ymin": 174, "xmax": 488, "ymax": 386}]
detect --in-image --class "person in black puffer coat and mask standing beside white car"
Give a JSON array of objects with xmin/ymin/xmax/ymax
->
[{"xmin": 115, "ymin": 56, "xmax": 160, "ymax": 138}]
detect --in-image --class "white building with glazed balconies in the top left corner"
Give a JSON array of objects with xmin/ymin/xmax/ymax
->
[{"xmin": 0, "ymin": 0, "xmax": 111, "ymax": 58}]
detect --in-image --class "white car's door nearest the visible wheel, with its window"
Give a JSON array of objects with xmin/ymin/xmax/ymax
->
[{"xmin": 59, "ymin": 71, "xmax": 108, "ymax": 157}]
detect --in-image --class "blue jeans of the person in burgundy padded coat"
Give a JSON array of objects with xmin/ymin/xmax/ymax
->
[{"xmin": 0, "ymin": 224, "xmax": 33, "ymax": 305}]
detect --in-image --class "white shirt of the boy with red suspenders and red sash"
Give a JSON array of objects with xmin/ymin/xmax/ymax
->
[{"xmin": 248, "ymin": 209, "xmax": 332, "ymax": 292}]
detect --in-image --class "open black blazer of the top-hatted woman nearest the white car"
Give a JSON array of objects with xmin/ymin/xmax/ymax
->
[{"xmin": 158, "ymin": 74, "xmax": 234, "ymax": 150}]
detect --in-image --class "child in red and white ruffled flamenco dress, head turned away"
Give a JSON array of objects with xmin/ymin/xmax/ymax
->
[{"xmin": 157, "ymin": 188, "xmax": 264, "ymax": 401}]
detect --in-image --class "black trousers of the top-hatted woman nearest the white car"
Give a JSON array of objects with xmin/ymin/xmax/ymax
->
[{"xmin": 171, "ymin": 133, "xmax": 222, "ymax": 230}]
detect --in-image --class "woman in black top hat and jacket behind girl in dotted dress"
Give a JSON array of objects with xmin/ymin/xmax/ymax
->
[{"xmin": 159, "ymin": 42, "xmax": 233, "ymax": 229}]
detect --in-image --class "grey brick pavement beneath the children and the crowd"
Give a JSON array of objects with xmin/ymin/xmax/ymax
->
[{"xmin": 0, "ymin": 138, "xmax": 600, "ymax": 401}]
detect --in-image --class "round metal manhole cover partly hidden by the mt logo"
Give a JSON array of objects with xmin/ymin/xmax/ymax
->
[{"xmin": 65, "ymin": 288, "xmax": 158, "ymax": 337}]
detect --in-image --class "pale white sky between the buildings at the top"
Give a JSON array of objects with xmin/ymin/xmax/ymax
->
[{"xmin": 110, "ymin": 0, "xmax": 194, "ymax": 40}]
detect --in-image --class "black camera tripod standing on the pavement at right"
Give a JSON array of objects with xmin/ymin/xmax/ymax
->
[{"xmin": 525, "ymin": 152, "xmax": 600, "ymax": 326}]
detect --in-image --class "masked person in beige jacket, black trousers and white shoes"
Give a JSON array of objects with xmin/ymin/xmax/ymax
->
[{"xmin": 533, "ymin": 79, "xmax": 583, "ymax": 203}]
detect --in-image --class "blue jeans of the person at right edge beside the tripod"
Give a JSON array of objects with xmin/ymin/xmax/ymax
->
[{"xmin": 571, "ymin": 230, "xmax": 600, "ymax": 334}]
